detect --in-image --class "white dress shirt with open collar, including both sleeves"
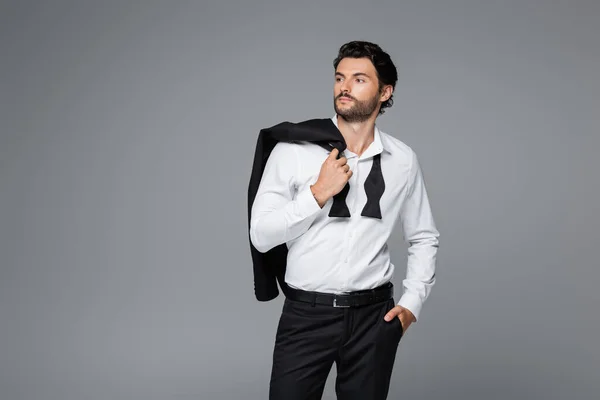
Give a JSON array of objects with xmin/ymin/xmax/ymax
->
[{"xmin": 250, "ymin": 116, "xmax": 439, "ymax": 319}]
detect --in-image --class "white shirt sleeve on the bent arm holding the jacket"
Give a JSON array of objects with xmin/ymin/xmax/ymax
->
[{"xmin": 250, "ymin": 142, "xmax": 321, "ymax": 253}]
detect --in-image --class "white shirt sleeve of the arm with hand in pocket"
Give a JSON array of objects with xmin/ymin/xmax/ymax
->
[{"xmin": 398, "ymin": 151, "xmax": 439, "ymax": 320}]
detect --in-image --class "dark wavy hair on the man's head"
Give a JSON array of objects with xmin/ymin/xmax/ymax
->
[{"xmin": 333, "ymin": 40, "xmax": 398, "ymax": 114}]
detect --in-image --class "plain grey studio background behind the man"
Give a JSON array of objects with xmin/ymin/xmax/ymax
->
[{"xmin": 0, "ymin": 0, "xmax": 600, "ymax": 400}]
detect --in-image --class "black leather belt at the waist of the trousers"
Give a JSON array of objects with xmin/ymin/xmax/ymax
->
[{"xmin": 285, "ymin": 282, "xmax": 394, "ymax": 307}]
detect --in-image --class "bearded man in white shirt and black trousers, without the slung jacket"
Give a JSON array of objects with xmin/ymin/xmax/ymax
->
[{"xmin": 249, "ymin": 41, "xmax": 439, "ymax": 400}]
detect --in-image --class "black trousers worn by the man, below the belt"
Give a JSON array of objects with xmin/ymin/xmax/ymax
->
[{"xmin": 269, "ymin": 298, "xmax": 403, "ymax": 400}]
